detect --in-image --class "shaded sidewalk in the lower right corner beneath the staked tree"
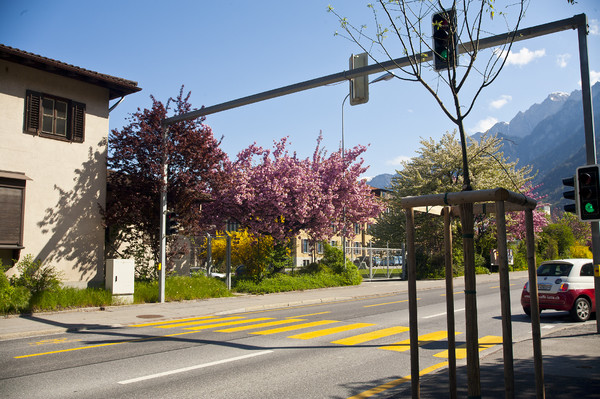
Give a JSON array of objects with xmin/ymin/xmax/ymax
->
[{"xmin": 414, "ymin": 320, "xmax": 600, "ymax": 399}]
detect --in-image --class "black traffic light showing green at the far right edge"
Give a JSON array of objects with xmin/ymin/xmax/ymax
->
[{"xmin": 575, "ymin": 165, "xmax": 600, "ymax": 222}]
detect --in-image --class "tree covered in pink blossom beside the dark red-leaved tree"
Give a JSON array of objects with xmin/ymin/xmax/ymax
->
[{"xmin": 204, "ymin": 137, "xmax": 383, "ymax": 242}]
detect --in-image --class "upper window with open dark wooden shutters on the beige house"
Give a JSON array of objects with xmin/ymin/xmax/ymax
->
[{"xmin": 24, "ymin": 90, "xmax": 85, "ymax": 143}]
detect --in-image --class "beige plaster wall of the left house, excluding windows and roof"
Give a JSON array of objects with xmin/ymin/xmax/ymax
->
[{"xmin": 0, "ymin": 60, "xmax": 109, "ymax": 286}]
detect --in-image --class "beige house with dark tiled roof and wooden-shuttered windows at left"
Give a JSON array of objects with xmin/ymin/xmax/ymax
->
[{"xmin": 0, "ymin": 45, "xmax": 141, "ymax": 286}]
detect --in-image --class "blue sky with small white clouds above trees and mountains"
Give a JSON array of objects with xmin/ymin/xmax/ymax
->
[{"xmin": 0, "ymin": 0, "xmax": 600, "ymax": 176}]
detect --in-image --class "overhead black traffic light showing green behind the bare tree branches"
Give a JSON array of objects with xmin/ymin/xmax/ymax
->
[{"xmin": 432, "ymin": 9, "xmax": 458, "ymax": 71}]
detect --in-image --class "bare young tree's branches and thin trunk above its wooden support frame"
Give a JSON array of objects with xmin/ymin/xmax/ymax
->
[{"xmin": 328, "ymin": 0, "xmax": 528, "ymax": 190}]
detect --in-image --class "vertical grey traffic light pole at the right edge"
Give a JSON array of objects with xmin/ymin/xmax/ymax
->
[{"xmin": 577, "ymin": 15, "xmax": 600, "ymax": 333}]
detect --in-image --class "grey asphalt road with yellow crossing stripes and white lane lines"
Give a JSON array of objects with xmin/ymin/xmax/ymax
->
[{"xmin": 0, "ymin": 279, "xmax": 584, "ymax": 399}]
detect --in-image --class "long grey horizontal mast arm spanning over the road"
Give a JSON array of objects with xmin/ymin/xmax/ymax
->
[{"xmin": 162, "ymin": 14, "xmax": 587, "ymax": 126}]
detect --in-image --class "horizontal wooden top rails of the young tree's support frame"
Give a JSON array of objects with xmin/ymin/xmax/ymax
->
[{"xmin": 400, "ymin": 188, "xmax": 537, "ymax": 210}]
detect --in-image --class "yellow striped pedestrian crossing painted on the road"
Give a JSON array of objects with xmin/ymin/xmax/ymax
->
[{"xmin": 131, "ymin": 312, "xmax": 502, "ymax": 359}]
